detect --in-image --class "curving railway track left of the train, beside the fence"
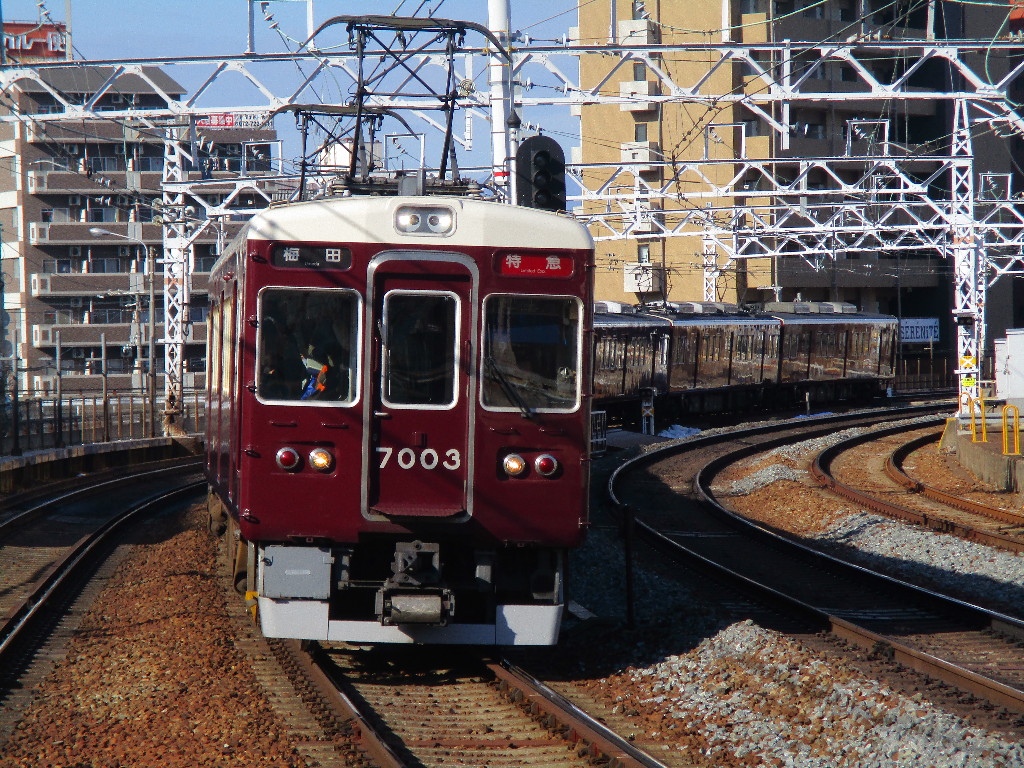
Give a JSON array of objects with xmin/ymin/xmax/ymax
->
[{"xmin": 0, "ymin": 460, "xmax": 203, "ymax": 693}]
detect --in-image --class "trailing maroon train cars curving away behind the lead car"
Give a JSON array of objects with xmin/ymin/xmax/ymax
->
[{"xmin": 594, "ymin": 305, "xmax": 897, "ymax": 413}]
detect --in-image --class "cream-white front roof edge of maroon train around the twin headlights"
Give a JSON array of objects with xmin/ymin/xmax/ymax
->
[{"xmin": 238, "ymin": 196, "xmax": 594, "ymax": 250}]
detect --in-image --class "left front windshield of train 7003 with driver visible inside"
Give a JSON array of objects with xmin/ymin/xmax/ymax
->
[{"xmin": 256, "ymin": 288, "xmax": 359, "ymax": 404}]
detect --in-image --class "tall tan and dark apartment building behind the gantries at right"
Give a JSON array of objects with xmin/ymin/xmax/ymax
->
[{"xmin": 573, "ymin": 0, "xmax": 1024, "ymax": 340}]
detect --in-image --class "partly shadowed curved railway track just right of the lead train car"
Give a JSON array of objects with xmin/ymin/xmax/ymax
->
[{"xmin": 608, "ymin": 413, "xmax": 1024, "ymax": 713}]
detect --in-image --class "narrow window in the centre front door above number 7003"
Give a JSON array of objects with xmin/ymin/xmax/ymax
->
[{"xmin": 382, "ymin": 291, "xmax": 459, "ymax": 408}]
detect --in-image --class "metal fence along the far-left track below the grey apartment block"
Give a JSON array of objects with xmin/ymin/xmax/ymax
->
[{"xmin": 0, "ymin": 392, "xmax": 206, "ymax": 456}]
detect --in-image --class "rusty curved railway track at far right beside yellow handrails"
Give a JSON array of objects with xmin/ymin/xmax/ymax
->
[{"xmin": 811, "ymin": 427, "xmax": 1024, "ymax": 552}]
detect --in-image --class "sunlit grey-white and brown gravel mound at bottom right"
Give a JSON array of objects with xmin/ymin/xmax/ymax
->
[{"xmin": 632, "ymin": 621, "xmax": 1024, "ymax": 768}]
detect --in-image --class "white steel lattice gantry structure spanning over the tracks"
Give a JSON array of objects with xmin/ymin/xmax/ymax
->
[{"xmin": 6, "ymin": 7, "xmax": 1024, "ymax": 410}]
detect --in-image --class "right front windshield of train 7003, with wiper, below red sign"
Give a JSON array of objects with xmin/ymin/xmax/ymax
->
[{"xmin": 481, "ymin": 294, "xmax": 583, "ymax": 414}]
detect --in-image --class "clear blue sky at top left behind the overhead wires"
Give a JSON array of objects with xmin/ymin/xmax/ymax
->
[{"xmin": 0, "ymin": 0, "xmax": 585, "ymax": 173}]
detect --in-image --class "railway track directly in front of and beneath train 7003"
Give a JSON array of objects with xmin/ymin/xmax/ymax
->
[{"xmin": 275, "ymin": 641, "xmax": 664, "ymax": 768}]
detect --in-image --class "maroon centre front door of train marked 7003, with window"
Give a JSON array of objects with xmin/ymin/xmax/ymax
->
[{"xmin": 362, "ymin": 252, "xmax": 478, "ymax": 519}]
